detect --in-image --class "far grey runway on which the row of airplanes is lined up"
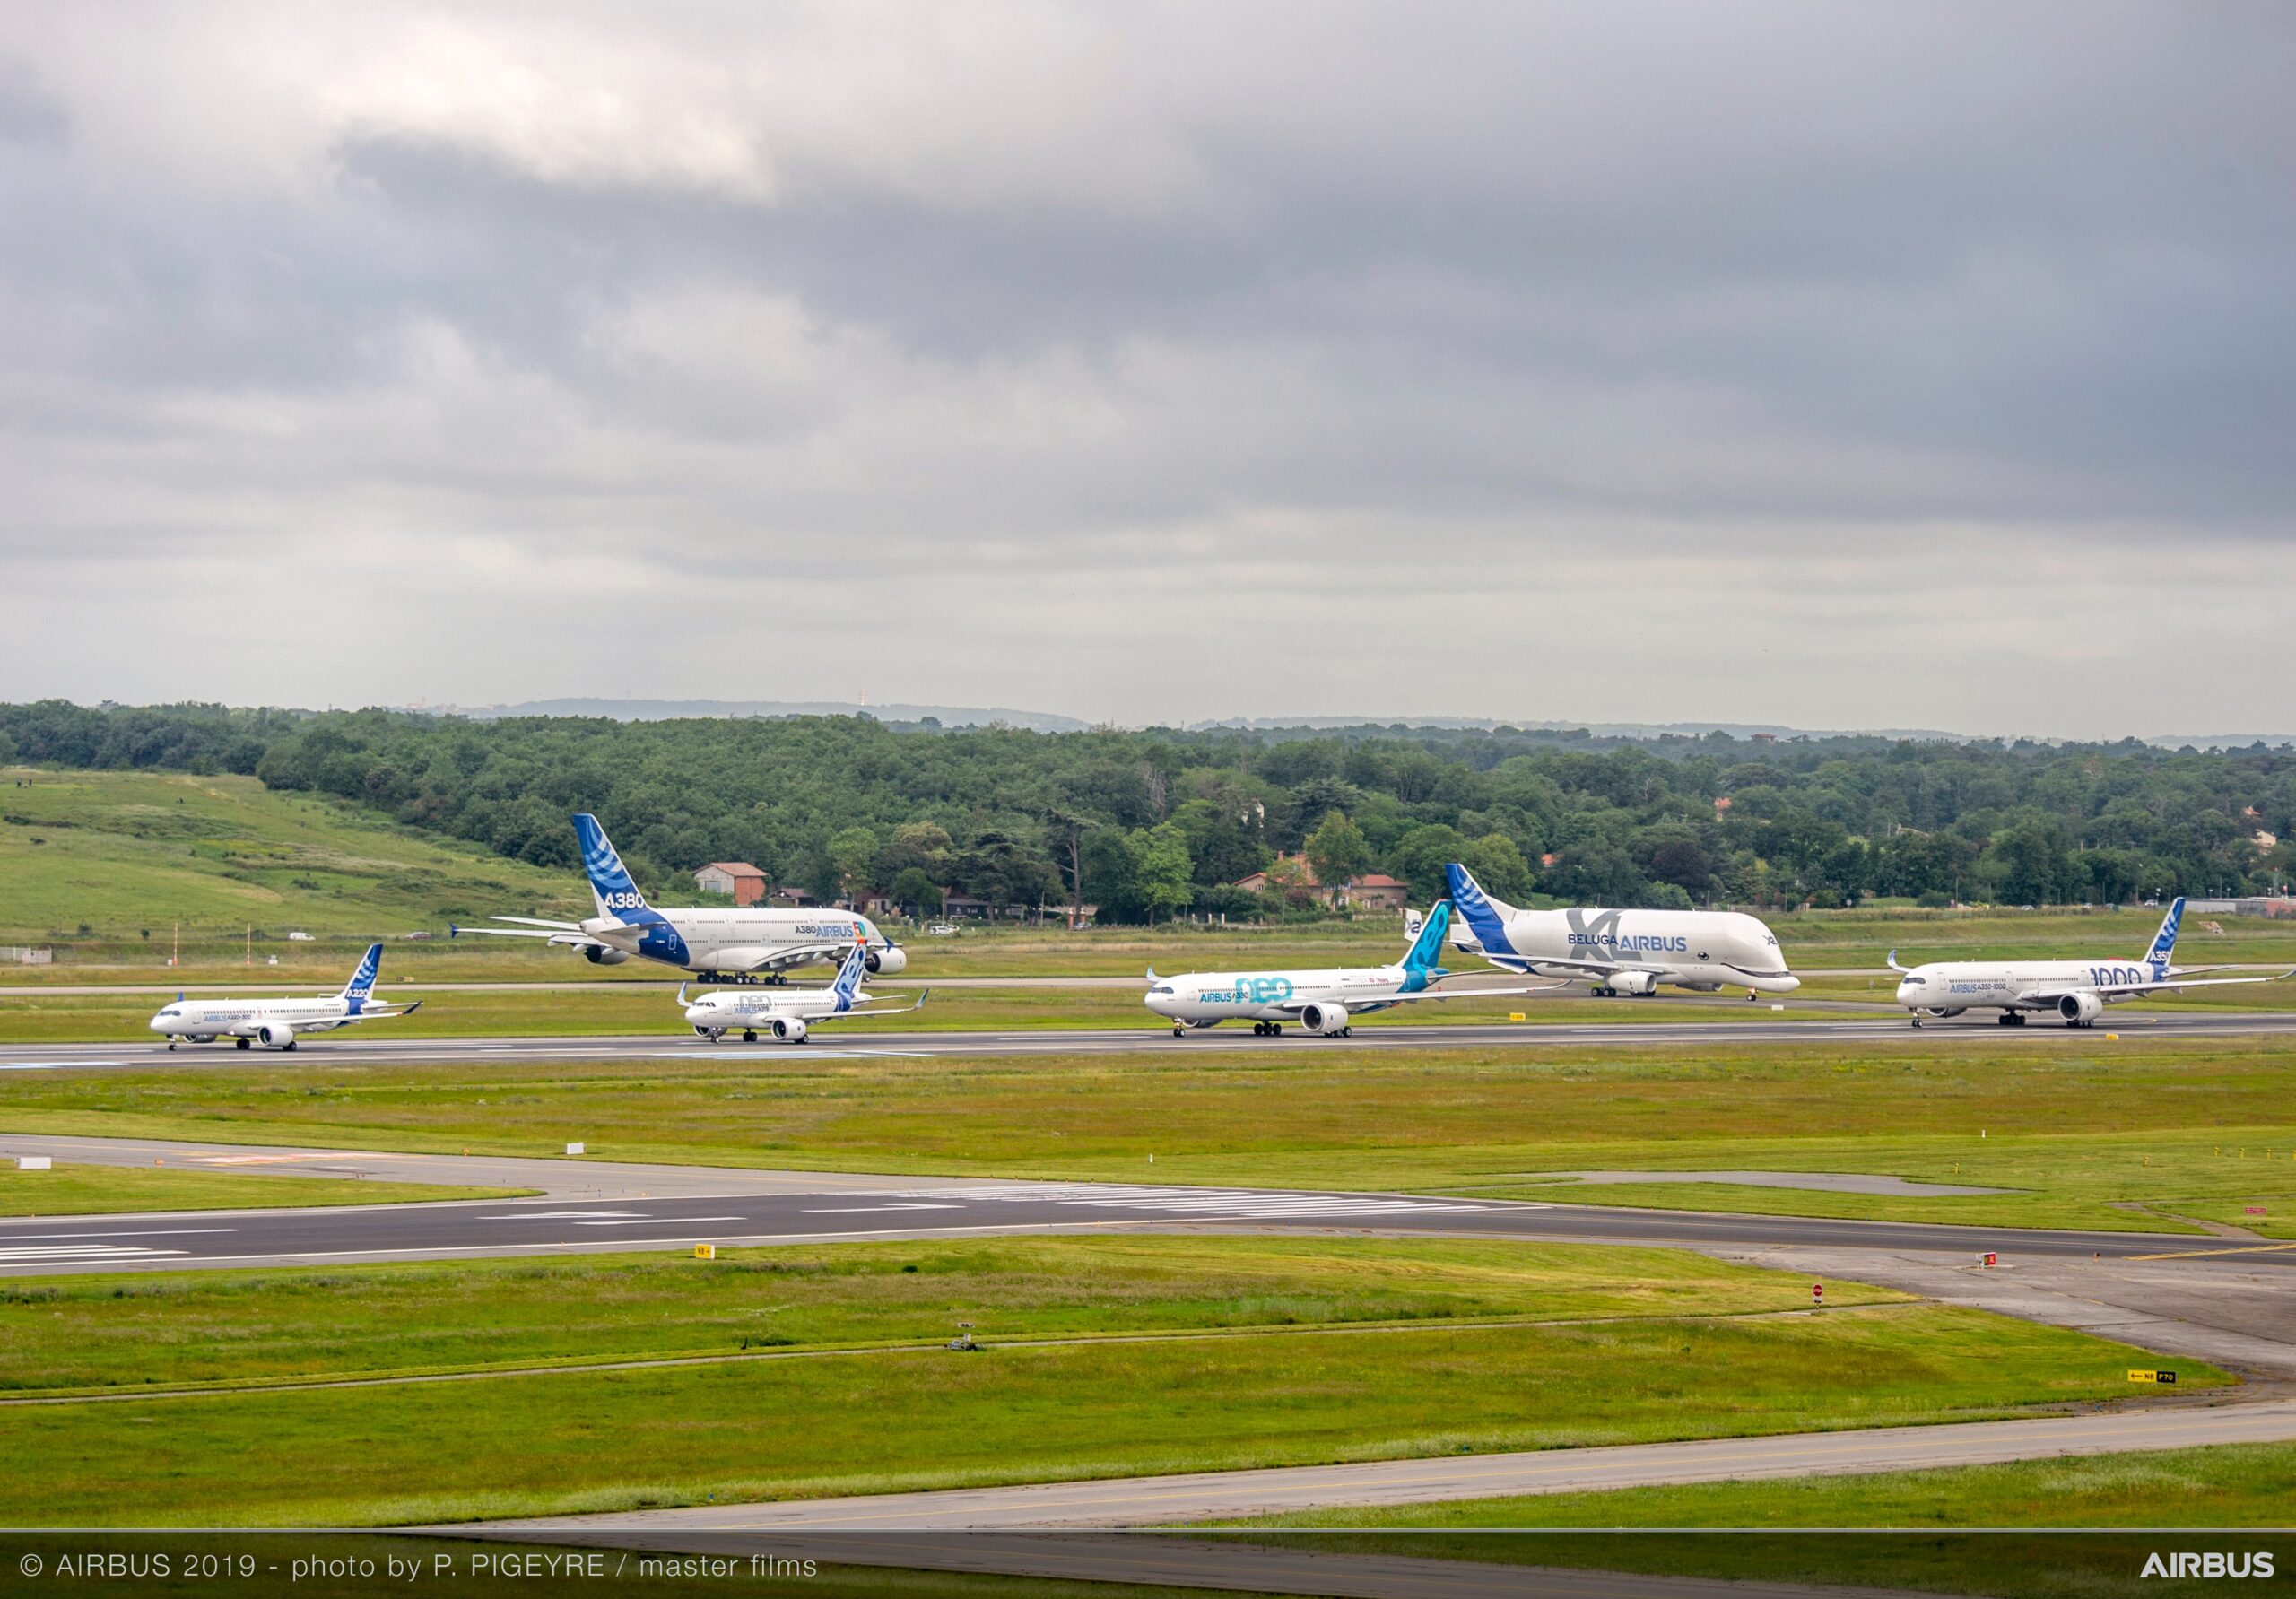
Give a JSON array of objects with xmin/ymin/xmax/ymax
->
[{"xmin": 13, "ymin": 999, "xmax": 2296, "ymax": 1071}]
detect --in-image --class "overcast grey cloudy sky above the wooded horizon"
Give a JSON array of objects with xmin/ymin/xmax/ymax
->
[{"xmin": 0, "ymin": 0, "xmax": 2296, "ymax": 735}]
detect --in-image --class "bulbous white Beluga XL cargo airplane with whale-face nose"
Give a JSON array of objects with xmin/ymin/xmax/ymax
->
[{"xmin": 1444, "ymin": 862, "xmax": 1803, "ymax": 999}]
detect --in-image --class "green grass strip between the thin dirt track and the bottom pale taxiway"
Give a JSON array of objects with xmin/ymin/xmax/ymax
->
[{"xmin": 0, "ymin": 1277, "xmax": 2195, "ymax": 1525}]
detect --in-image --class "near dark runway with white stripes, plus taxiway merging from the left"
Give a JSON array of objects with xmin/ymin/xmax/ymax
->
[{"xmin": 0, "ymin": 1135, "xmax": 2296, "ymax": 1275}]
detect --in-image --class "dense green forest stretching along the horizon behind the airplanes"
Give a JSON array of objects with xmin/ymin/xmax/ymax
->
[{"xmin": 0, "ymin": 700, "xmax": 2296, "ymax": 921}]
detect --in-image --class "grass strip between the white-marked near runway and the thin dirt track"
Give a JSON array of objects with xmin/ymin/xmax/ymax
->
[{"xmin": 0, "ymin": 1236, "xmax": 1906, "ymax": 1392}]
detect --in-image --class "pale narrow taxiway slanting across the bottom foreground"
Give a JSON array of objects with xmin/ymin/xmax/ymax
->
[{"xmin": 470, "ymin": 1399, "xmax": 2296, "ymax": 1542}]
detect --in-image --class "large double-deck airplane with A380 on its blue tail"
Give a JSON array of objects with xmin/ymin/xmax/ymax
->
[{"xmin": 448, "ymin": 811, "xmax": 909, "ymax": 983}]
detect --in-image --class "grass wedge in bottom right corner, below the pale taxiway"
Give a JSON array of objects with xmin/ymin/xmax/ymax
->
[{"xmin": 1245, "ymin": 1443, "xmax": 2296, "ymax": 1528}]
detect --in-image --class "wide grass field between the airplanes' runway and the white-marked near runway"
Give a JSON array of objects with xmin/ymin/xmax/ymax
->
[{"xmin": 0, "ymin": 1034, "xmax": 2296, "ymax": 1236}]
